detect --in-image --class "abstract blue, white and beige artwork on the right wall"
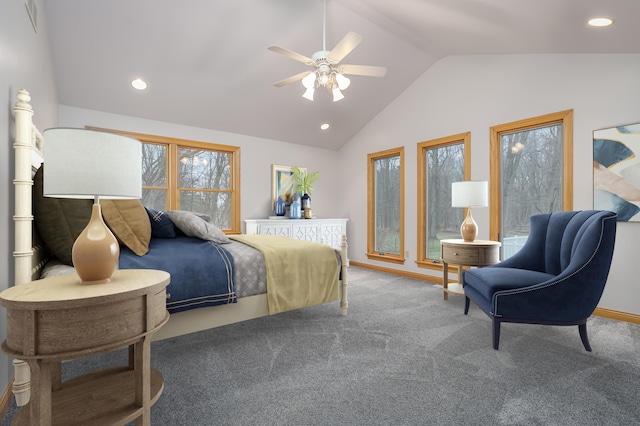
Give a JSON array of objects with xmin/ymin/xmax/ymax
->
[{"xmin": 593, "ymin": 123, "xmax": 640, "ymax": 222}]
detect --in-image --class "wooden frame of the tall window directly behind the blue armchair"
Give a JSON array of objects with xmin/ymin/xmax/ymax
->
[{"xmin": 489, "ymin": 109, "xmax": 573, "ymax": 241}]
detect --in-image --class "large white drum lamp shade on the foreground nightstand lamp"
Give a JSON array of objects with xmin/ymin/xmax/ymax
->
[{"xmin": 43, "ymin": 128, "xmax": 142, "ymax": 199}]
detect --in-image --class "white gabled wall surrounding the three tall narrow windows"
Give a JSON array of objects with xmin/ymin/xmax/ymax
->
[{"xmin": 340, "ymin": 55, "xmax": 640, "ymax": 314}]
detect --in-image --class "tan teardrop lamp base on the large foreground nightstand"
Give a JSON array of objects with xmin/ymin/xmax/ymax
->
[{"xmin": 71, "ymin": 204, "xmax": 120, "ymax": 284}]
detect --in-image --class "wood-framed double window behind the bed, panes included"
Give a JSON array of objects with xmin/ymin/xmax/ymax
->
[{"xmin": 90, "ymin": 129, "xmax": 240, "ymax": 233}]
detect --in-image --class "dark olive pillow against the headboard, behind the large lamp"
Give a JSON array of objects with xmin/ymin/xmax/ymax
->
[{"xmin": 33, "ymin": 166, "xmax": 93, "ymax": 265}]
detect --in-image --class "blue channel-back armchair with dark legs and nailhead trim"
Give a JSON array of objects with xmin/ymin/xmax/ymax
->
[{"xmin": 462, "ymin": 210, "xmax": 617, "ymax": 352}]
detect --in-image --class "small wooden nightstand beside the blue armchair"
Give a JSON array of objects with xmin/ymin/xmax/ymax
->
[{"xmin": 440, "ymin": 239, "xmax": 501, "ymax": 300}]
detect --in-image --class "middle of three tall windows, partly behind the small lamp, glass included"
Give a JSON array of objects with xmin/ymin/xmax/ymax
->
[{"xmin": 416, "ymin": 132, "xmax": 471, "ymax": 269}]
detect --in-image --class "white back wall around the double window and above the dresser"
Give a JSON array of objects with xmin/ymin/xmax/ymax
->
[{"xmin": 60, "ymin": 106, "xmax": 340, "ymax": 223}]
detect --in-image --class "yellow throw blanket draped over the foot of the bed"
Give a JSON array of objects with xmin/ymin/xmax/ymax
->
[{"xmin": 229, "ymin": 234, "xmax": 340, "ymax": 315}]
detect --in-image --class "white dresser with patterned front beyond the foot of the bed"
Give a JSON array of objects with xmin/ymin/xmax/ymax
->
[{"xmin": 244, "ymin": 219, "xmax": 349, "ymax": 249}]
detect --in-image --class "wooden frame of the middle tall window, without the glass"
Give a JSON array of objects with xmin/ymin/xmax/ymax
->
[{"xmin": 416, "ymin": 132, "xmax": 471, "ymax": 270}]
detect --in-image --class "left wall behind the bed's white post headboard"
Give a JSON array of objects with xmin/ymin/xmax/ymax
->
[{"xmin": 0, "ymin": 0, "xmax": 58, "ymax": 394}]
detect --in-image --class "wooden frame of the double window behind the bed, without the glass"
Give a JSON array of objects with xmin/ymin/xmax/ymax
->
[{"xmin": 86, "ymin": 126, "xmax": 242, "ymax": 234}]
